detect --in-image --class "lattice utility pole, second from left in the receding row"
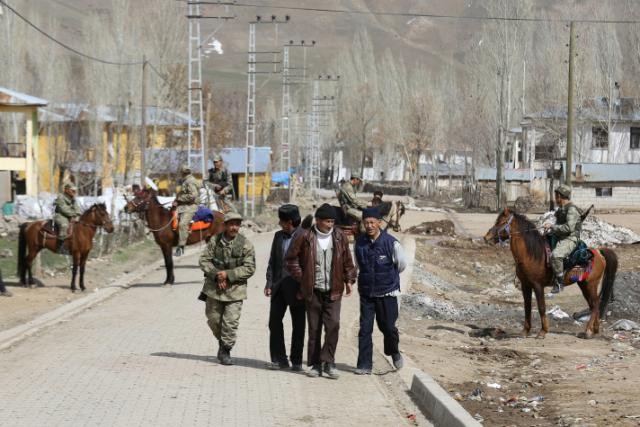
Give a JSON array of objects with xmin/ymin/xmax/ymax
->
[{"xmin": 243, "ymin": 15, "xmax": 290, "ymax": 217}]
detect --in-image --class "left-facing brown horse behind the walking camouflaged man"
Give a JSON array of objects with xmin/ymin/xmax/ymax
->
[{"xmin": 124, "ymin": 189, "xmax": 224, "ymax": 285}]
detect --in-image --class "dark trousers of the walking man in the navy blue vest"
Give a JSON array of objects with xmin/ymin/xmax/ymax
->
[{"xmin": 358, "ymin": 295, "xmax": 400, "ymax": 369}]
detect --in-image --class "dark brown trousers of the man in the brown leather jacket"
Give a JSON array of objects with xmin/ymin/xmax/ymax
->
[{"xmin": 307, "ymin": 290, "xmax": 342, "ymax": 366}]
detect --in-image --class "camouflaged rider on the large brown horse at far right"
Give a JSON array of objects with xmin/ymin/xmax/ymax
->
[{"xmin": 544, "ymin": 185, "xmax": 582, "ymax": 294}]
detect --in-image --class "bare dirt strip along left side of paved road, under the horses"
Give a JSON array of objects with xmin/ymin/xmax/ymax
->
[{"xmin": 0, "ymin": 240, "xmax": 162, "ymax": 330}]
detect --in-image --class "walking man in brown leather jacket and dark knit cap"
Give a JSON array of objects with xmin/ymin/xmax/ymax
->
[{"xmin": 286, "ymin": 203, "xmax": 356, "ymax": 379}]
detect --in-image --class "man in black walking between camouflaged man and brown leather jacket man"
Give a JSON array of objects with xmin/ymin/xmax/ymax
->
[{"xmin": 264, "ymin": 204, "xmax": 305, "ymax": 371}]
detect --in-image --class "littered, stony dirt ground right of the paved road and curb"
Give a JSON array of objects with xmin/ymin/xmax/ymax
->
[{"xmin": 399, "ymin": 212, "xmax": 640, "ymax": 426}]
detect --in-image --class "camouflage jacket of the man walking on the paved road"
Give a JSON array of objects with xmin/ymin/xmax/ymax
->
[{"xmin": 200, "ymin": 233, "xmax": 256, "ymax": 301}]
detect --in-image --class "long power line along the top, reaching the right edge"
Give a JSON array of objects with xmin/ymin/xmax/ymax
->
[{"xmin": 189, "ymin": 1, "xmax": 640, "ymax": 24}]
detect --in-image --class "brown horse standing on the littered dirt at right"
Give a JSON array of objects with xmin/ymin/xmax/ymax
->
[{"xmin": 484, "ymin": 208, "xmax": 618, "ymax": 338}]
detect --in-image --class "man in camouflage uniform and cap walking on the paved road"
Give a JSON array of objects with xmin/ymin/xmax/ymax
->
[{"xmin": 200, "ymin": 212, "xmax": 256, "ymax": 365}]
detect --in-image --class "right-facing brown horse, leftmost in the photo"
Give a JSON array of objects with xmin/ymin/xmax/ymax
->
[{"xmin": 18, "ymin": 203, "xmax": 113, "ymax": 292}]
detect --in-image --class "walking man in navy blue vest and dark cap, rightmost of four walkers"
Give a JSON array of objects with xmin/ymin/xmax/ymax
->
[{"xmin": 355, "ymin": 207, "xmax": 406, "ymax": 375}]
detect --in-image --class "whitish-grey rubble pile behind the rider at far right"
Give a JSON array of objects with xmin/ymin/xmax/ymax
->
[{"xmin": 537, "ymin": 212, "xmax": 640, "ymax": 246}]
